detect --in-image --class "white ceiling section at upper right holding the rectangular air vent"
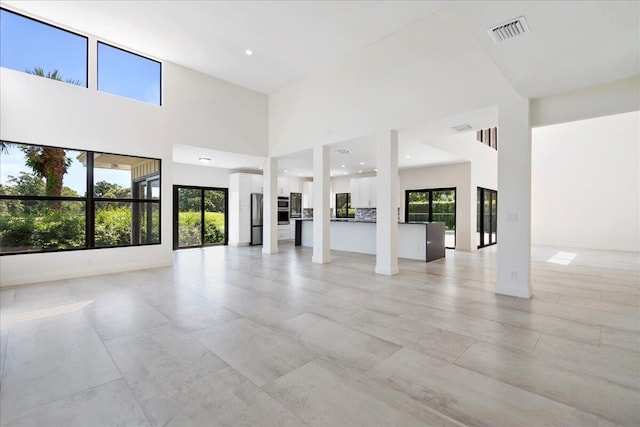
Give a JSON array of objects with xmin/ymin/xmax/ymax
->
[{"xmin": 454, "ymin": 1, "xmax": 640, "ymax": 98}]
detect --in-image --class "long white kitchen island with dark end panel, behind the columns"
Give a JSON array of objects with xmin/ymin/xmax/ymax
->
[{"xmin": 295, "ymin": 219, "xmax": 445, "ymax": 262}]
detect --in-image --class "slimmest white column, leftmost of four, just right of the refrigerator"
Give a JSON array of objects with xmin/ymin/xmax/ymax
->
[{"xmin": 262, "ymin": 157, "xmax": 278, "ymax": 254}]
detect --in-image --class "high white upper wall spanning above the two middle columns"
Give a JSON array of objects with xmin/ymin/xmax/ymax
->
[{"xmin": 269, "ymin": 7, "xmax": 516, "ymax": 156}]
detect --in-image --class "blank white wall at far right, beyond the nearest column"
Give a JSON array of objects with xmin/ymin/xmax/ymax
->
[{"xmin": 528, "ymin": 111, "xmax": 640, "ymax": 251}]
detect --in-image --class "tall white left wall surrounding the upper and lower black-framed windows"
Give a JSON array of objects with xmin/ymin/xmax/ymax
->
[{"xmin": 0, "ymin": 26, "xmax": 268, "ymax": 286}]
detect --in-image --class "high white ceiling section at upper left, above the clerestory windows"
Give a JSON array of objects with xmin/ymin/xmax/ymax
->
[{"xmin": 3, "ymin": 0, "xmax": 442, "ymax": 94}]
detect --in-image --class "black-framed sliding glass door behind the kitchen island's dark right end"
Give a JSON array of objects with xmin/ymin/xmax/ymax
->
[{"xmin": 404, "ymin": 188, "xmax": 456, "ymax": 249}]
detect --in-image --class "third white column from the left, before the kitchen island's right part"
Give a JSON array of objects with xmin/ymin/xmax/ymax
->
[{"xmin": 376, "ymin": 130, "xmax": 400, "ymax": 276}]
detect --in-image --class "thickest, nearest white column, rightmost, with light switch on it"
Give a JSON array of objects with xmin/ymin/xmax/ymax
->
[{"xmin": 496, "ymin": 99, "xmax": 533, "ymax": 298}]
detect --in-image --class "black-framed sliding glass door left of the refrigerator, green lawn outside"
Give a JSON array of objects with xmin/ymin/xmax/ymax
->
[{"xmin": 173, "ymin": 185, "xmax": 228, "ymax": 249}]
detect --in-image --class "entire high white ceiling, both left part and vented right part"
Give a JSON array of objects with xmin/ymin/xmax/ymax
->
[{"xmin": 2, "ymin": 0, "xmax": 640, "ymax": 97}]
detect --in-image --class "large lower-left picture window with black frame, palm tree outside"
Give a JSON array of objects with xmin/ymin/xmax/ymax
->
[{"xmin": 0, "ymin": 142, "xmax": 160, "ymax": 255}]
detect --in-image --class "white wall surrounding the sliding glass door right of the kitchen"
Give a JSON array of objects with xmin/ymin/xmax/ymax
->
[{"xmin": 400, "ymin": 162, "xmax": 476, "ymax": 251}]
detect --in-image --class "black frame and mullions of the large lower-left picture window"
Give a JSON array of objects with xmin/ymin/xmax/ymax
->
[{"xmin": 0, "ymin": 140, "xmax": 162, "ymax": 257}]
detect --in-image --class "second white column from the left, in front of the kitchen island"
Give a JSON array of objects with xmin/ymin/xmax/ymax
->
[{"xmin": 311, "ymin": 146, "xmax": 331, "ymax": 264}]
